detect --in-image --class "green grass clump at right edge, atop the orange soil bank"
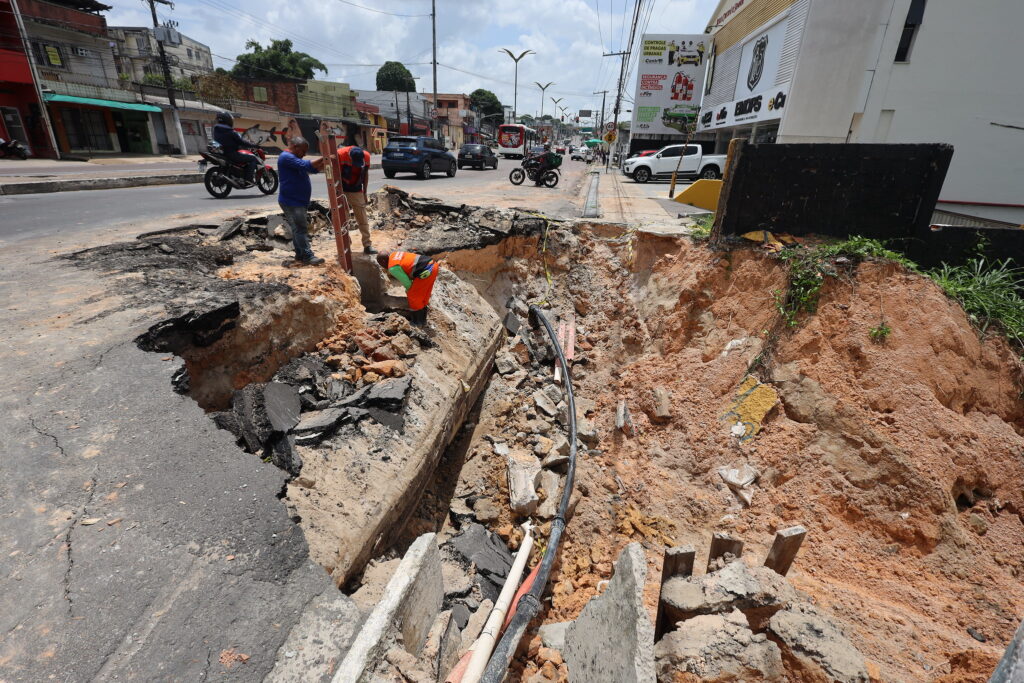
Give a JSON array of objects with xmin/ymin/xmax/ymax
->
[{"xmin": 928, "ymin": 256, "xmax": 1024, "ymax": 350}]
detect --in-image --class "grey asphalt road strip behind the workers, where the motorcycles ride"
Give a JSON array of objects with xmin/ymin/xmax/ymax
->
[{"xmin": 0, "ymin": 160, "xmax": 586, "ymax": 243}]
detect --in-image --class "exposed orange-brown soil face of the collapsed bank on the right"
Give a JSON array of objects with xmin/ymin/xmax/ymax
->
[{"xmin": 449, "ymin": 226, "xmax": 1024, "ymax": 680}]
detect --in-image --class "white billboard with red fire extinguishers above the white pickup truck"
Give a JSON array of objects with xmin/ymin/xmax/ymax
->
[{"xmin": 630, "ymin": 33, "xmax": 711, "ymax": 137}]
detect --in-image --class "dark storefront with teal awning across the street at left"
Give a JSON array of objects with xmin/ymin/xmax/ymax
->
[{"xmin": 45, "ymin": 93, "xmax": 161, "ymax": 155}]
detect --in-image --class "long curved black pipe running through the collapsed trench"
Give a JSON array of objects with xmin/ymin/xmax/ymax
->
[{"xmin": 480, "ymin": 306, "xmax": 577, "ymax": 683}]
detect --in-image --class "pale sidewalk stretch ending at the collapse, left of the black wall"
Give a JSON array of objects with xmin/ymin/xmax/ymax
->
[{"xmin": 593, "ymin": 163, "xmax": 702, "ymax": 232}]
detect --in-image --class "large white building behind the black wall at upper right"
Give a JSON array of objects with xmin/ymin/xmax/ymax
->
[{"xmin": 699, "ymin": 0, "xmax": 1024, "ymax": 224}]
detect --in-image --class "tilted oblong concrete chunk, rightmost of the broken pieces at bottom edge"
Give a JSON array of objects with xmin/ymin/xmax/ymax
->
[{"xmin": 768, "ymin": 604, "xmax": 868, "ymax": 683}]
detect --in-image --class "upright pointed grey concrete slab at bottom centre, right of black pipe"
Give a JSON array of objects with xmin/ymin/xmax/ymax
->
[{"xmin": 562, "ymin": 543, "xmax": 654, "ymax": 683}]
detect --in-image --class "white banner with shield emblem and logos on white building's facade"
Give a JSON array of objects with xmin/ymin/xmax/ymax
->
[{"xmin": 697, "ymin": 18, "xmax": 790, "ymax": 131}]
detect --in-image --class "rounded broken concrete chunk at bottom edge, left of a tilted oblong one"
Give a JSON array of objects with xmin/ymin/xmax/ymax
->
[{"xmin": 654, "ymin": 611, "xmax": 785, "ymax": 681}]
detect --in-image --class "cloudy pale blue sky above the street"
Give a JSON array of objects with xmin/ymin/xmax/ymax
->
[{"xmin": 104, "ymin": 0, "xmax": 717, "ymax": 123}]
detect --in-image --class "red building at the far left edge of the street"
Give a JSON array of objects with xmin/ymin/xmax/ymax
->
[{"xmin": 0, "ymin": 0, "xmax": 56, "ymax": 157}]
